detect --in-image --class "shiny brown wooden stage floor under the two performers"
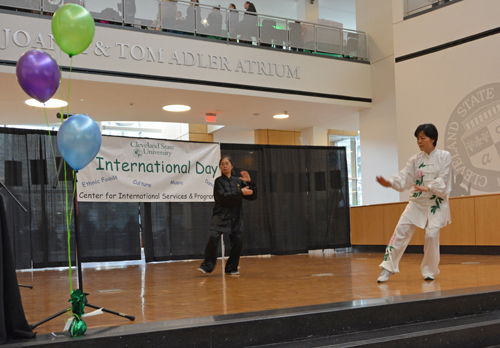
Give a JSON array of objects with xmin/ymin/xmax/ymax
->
[{"xmin": 17, "ymin": 253, "xmax": 500, "ymax": 334}]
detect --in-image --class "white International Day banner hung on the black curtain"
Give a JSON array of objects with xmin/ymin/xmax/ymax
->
[{"xmin": 77, "ymin": 136, "xmax": 220, "ymax": 202}]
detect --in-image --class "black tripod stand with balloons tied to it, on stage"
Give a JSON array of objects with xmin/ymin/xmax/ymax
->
[{"xmin": 30, "ymin": 170, "xmax": 135, "ymax": 329}]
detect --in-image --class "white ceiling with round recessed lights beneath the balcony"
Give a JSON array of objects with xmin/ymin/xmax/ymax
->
[{"xmin": 0, "ymin": 69, "xmax": 364, "ymax": 131}]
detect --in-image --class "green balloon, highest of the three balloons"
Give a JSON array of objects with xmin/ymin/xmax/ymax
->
[{"xmin": 52, "ymin": 4, "xmax": 95, "ymax": 57}]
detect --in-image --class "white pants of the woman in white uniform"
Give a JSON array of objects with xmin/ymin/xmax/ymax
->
[{"xmin": 379, "ymin": 222, "xmax": 440, "ymax": 277}]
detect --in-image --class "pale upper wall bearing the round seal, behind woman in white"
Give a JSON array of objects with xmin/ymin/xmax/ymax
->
[{"xmin": 394, "ymin": 0, "xmax": 500, "ymax": 195}]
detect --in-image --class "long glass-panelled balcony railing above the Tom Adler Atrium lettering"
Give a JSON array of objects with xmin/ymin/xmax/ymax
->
[{"xmin": 0, "ymin": 0, "xmax": 368, "ymax": 60}]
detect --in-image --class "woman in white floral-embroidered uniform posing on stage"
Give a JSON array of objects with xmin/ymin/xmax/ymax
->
[{"xmin": 377, "ymin": 123, "xmax": 452, "ymax": 283}]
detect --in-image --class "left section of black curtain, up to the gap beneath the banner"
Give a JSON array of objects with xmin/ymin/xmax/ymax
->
[{"xmin": 0, "ymin": 128, "xmax": 141, "ymax": 269}]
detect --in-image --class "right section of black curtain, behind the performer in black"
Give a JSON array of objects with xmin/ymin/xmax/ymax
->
[{"xmin": 141, "ymin": 144, "xmax": 351, "ymax": 261}]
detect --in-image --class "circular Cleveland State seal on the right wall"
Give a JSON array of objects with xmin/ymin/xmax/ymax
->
[{"xmin": 444, "ymin": 83, "xmax": 500, "ymax": 192}]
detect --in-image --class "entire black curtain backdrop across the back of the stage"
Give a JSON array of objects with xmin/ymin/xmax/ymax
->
[{"xmin": 0, "ymin": 128, "xmax": 350, "ymax": 269}]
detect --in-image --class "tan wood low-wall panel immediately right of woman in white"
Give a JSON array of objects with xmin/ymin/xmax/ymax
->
[{"xmin": 440, "ymin": 197, "xmax": 476, "ymax": 245}]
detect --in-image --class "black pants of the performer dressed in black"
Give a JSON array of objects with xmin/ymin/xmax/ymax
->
[{"xmin": 201, "ymin": 230, "xmax": 243, "ymax": 273}]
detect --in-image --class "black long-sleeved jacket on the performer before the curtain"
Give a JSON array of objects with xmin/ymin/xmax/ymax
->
[{"xmin": 210, "ymin": 175, "xmax": 257, "ymax": 234}]
